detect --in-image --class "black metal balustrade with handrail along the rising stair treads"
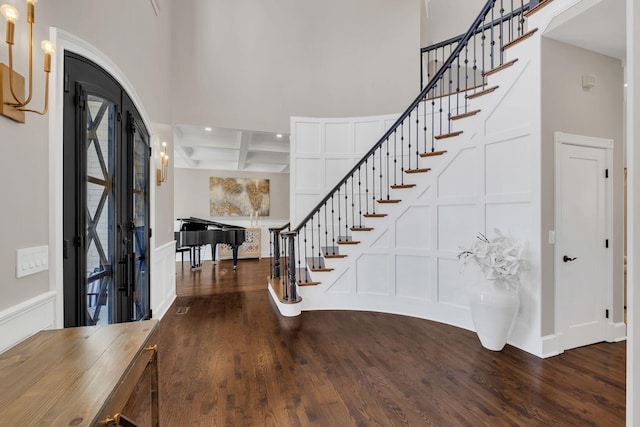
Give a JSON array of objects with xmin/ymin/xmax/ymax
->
[{"xmin": 282, "ymin": 0, "xmax": 526, "ymax": 301}]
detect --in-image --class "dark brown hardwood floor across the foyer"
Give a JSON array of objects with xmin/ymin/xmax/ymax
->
[{"xmin": 125, "ymin": 259, "xmax": 625, "ymax": 427}]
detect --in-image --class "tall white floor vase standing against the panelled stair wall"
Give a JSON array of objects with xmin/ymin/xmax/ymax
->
[{"xmin": 469, "ymin": 279, "xmax": 520, "ymax": 351}]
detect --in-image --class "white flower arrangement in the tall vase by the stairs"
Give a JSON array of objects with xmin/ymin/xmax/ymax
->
[{"xmin": 458, "ymin": 228, "xmax": 525, "ymax": 283}]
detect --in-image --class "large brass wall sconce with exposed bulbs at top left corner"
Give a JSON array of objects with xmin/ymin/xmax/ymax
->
[{"xmin": 0, "ymin": 0, "xmax": 56, "ymax": 123}]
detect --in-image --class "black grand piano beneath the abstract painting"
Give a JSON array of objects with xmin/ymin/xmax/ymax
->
[{"xmin": 175, "ymin": 217, "xmax": 245, "ymax": 270}]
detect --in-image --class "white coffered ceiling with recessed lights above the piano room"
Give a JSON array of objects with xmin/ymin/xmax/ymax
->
[{"xmin": 174, "ymin": 125, "xmax": 289, "ymax": 173}]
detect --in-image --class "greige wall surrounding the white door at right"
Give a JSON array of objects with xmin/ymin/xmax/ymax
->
[{"xmin": 540, "ymin": 37, "xmax": 624, "ymax": 335}]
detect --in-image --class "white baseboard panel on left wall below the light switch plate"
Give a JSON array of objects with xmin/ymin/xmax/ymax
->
[{"xmin": 0, "ymin": 291, "xmax": 56, "ymax": 353}]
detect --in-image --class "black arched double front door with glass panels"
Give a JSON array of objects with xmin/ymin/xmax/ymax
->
[{"xmin": 63, "ymin": 52, "xmax": 151, "ymax": 327}]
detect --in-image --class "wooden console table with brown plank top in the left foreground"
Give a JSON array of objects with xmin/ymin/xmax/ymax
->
[{"xmin": 0, "ymin": 320, "xmax": 159, "ymax": 426}]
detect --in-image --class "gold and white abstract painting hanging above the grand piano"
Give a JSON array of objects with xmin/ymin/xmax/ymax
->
[{"xmin": 209, "ymin": 177, "xmax": 269, "ymax": 216}]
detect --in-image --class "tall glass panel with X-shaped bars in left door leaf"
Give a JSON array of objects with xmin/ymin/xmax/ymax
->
[{"xmin": 85, "ymin": 95, "xmax": 116, "ymax": 325}]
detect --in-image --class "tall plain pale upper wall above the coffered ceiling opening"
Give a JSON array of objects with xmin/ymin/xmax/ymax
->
[{"xmin": 173, "ymin": 0, "xmax": 422, "ymax": 133}]
